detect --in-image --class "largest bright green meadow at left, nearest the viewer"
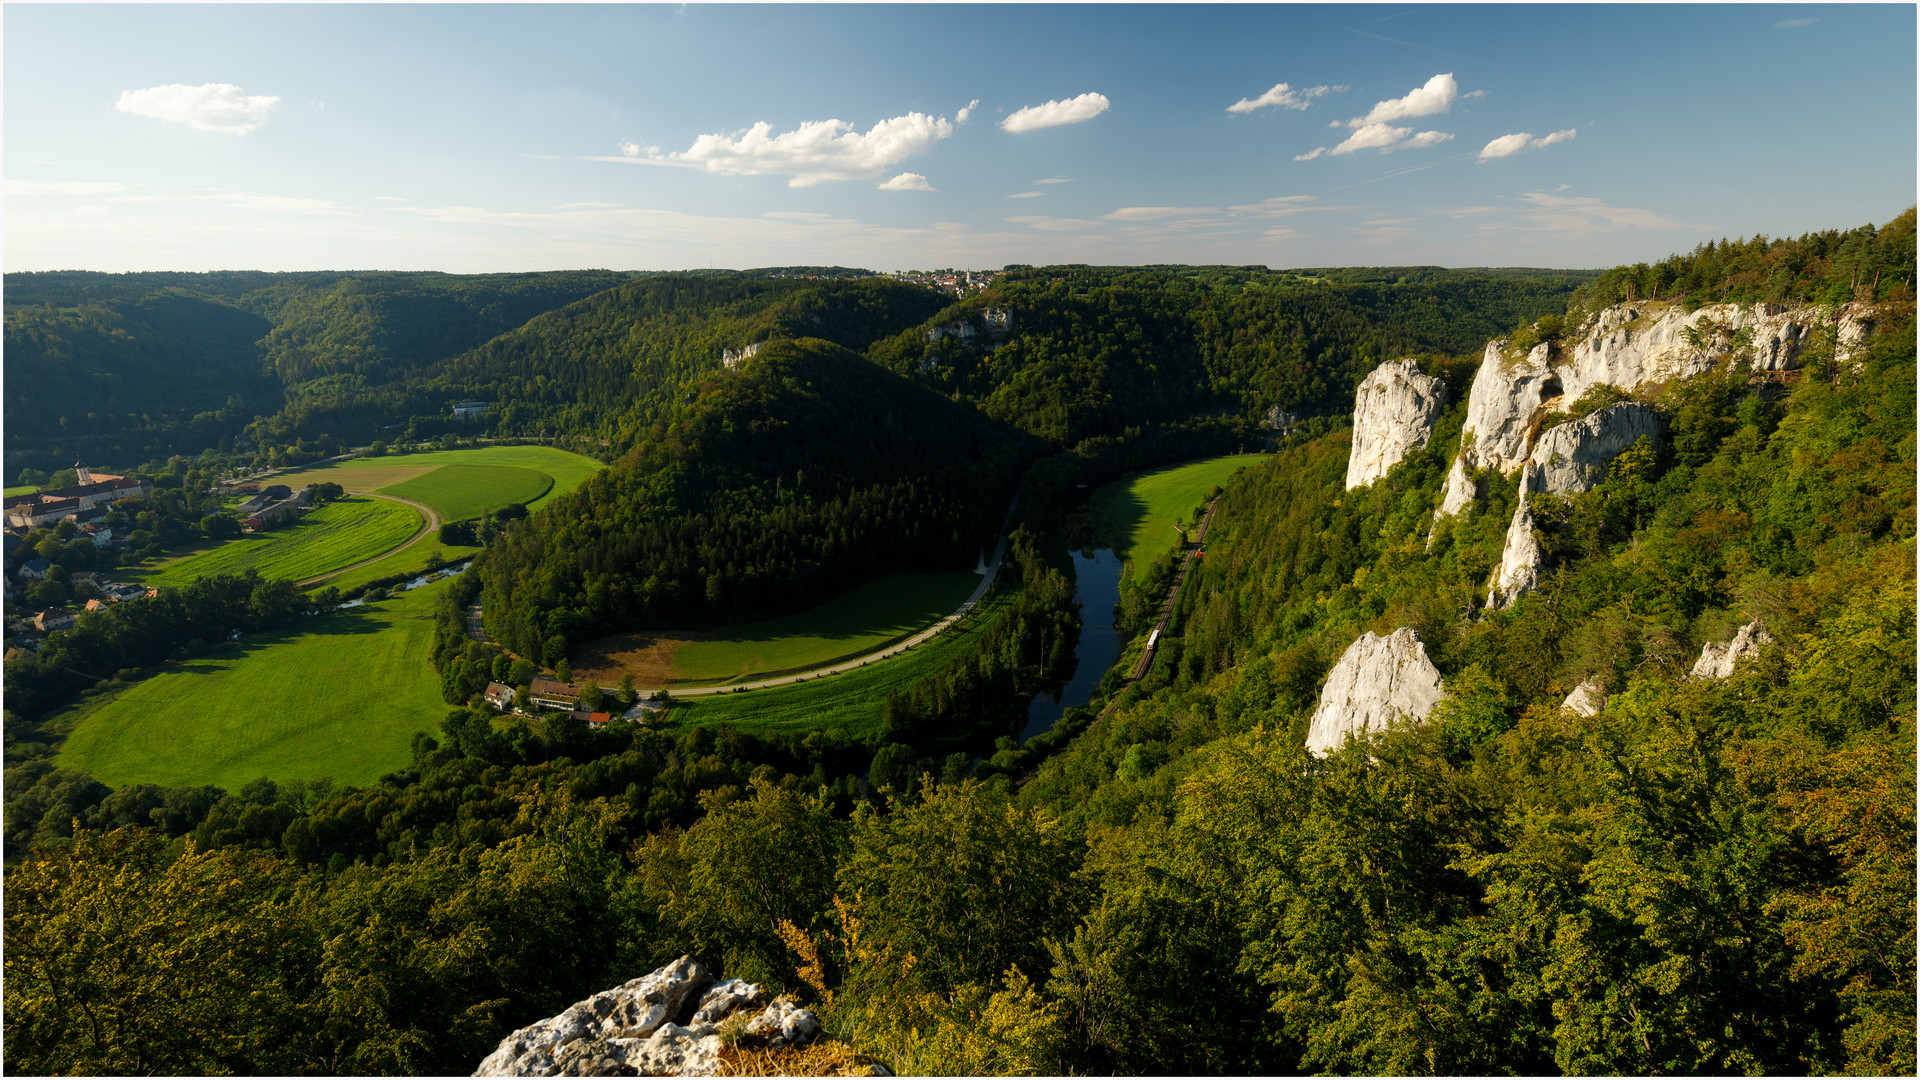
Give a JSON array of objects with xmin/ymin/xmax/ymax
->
[{"xmin": 56, "ymin": 582, "xmax": 447, "ymax": 792}]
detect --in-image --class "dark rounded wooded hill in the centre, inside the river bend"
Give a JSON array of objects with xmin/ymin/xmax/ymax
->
[{"xmin": 480, "ymin": 338, "xmax": 1039, "ymax": 665}]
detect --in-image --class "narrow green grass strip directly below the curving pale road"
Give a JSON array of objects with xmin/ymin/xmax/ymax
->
[{"xmin": 668, "ymin": 578, "xmax": 1020, "ymax": 736}]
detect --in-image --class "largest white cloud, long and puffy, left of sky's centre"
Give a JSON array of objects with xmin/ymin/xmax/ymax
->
[{"xmin": 652, "ymin": 113, "xmax": 954, "ymax": 188}]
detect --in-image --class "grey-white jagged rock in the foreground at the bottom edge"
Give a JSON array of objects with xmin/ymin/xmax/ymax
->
[{"xmin": 474, "ymin": 957, "xmax": 820, "ymax": 1076}]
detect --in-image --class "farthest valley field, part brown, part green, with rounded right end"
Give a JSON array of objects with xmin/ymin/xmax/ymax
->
[{"xmin": 263, "ymin": 446, "xmax": 605, "ymax": 521}]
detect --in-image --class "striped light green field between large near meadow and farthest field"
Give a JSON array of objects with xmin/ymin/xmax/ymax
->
[{"xmin": 121, "ymin": 498, "xmax": 424, "ymax": 586}]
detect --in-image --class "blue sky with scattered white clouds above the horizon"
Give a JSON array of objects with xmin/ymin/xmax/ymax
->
[{"xmin": 4, "ymin": 4, "xmax": 1916, "ymax": 273}]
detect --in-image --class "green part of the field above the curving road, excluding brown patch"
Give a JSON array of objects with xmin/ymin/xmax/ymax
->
[{"xmin": 674, "ymin": 571, "xmax": 979, "ymax": 682}]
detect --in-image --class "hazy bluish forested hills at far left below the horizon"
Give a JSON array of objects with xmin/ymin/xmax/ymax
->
[{"xmin": 6, "ymin": 271, "xmax": 626, "ymax": 469}]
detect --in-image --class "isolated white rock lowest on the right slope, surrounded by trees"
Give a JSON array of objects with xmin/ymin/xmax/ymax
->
[{"xmin": 1308, "ymin": 626, "xmax": 1446, "ymax": 753}]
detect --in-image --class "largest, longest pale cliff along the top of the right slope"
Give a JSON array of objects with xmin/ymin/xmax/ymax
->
[{"xmin": 1436, "ymin": 304, "xmax": 1827, "ymax": 519}]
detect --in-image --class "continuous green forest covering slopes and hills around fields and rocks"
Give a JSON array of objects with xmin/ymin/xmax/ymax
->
[{"xmin": 0, "ymin": 209, "xmax": 1916, "ymax": 1074}]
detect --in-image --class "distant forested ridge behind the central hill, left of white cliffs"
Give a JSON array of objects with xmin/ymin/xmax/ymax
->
[{"xmin": 868, "ymin": 267, "xmax": 1594, "ymax": 446}]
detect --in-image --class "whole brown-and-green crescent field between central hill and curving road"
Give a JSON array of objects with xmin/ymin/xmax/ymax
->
[{"xmin": 570, "ymin": 571, "xmax": 979, "ymax": 686}]
